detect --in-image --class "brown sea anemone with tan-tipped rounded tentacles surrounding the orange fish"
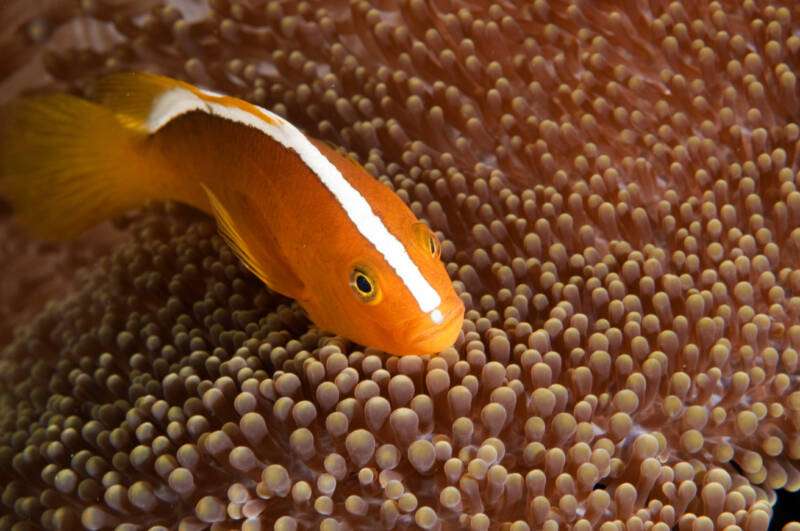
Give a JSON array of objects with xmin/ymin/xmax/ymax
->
[{"xmin": 0, "ymin": 0, "xmax": 800, "ymax": 530}]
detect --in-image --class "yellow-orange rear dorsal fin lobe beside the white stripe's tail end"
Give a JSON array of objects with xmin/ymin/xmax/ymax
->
[{"xmin": 89, "ymin": 72, "xmax": 201, "ymax": 133}]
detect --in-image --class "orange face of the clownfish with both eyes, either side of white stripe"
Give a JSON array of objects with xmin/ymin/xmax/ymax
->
[{"xmin": 301, "ymin": 221, "xmax": 464, "ymax": 356}]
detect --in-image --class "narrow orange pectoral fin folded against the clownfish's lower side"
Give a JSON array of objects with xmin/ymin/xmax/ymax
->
[{"xmin": 200, "ymin": 183, "xmax": 305, "ymax": 299}]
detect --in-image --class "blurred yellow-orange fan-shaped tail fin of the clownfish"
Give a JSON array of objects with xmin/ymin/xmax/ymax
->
[{"xmin": 0, "ymin": 94, "xmax": 150, "ymax": 239}]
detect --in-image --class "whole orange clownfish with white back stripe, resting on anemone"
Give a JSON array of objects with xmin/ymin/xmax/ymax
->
[{"xmin": 0, "ymin": 69, "xmax": 464, "ymax": 355}]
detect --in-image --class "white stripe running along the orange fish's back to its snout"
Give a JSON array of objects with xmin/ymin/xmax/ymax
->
[{"xmin": 147, "ymin": 88, "xmax": 442, "ymax": 319}]
